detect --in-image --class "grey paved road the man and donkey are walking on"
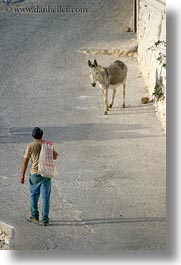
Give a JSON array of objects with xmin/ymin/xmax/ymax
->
[{"xmin": 0, "ymin": 0, "xmax": 166, "ymax": 250}]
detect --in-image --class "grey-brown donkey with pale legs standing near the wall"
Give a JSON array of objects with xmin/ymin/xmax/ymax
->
[{"xmin": 88, "ymin": 60, "xmax": 128, "ymax": 115}]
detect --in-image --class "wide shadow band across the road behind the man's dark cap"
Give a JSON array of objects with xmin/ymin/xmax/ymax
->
[{"xmin": 0, "ymin": 123, "xmax": 162, "ymax": 144}]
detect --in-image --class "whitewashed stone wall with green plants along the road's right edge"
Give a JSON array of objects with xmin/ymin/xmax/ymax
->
[{"xmin": 137, "ymin": 0, "xmax": 166, "ymax": 129}]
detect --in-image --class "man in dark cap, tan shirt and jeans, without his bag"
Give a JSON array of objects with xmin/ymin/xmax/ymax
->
[{"xmin": 20, "ymin": 127, "xmax": 58, "ymax": 226}]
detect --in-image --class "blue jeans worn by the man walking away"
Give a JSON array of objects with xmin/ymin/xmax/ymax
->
[{"xmin": 29, "ymin": 173, "xmax": 51, "ymax": 222}]
